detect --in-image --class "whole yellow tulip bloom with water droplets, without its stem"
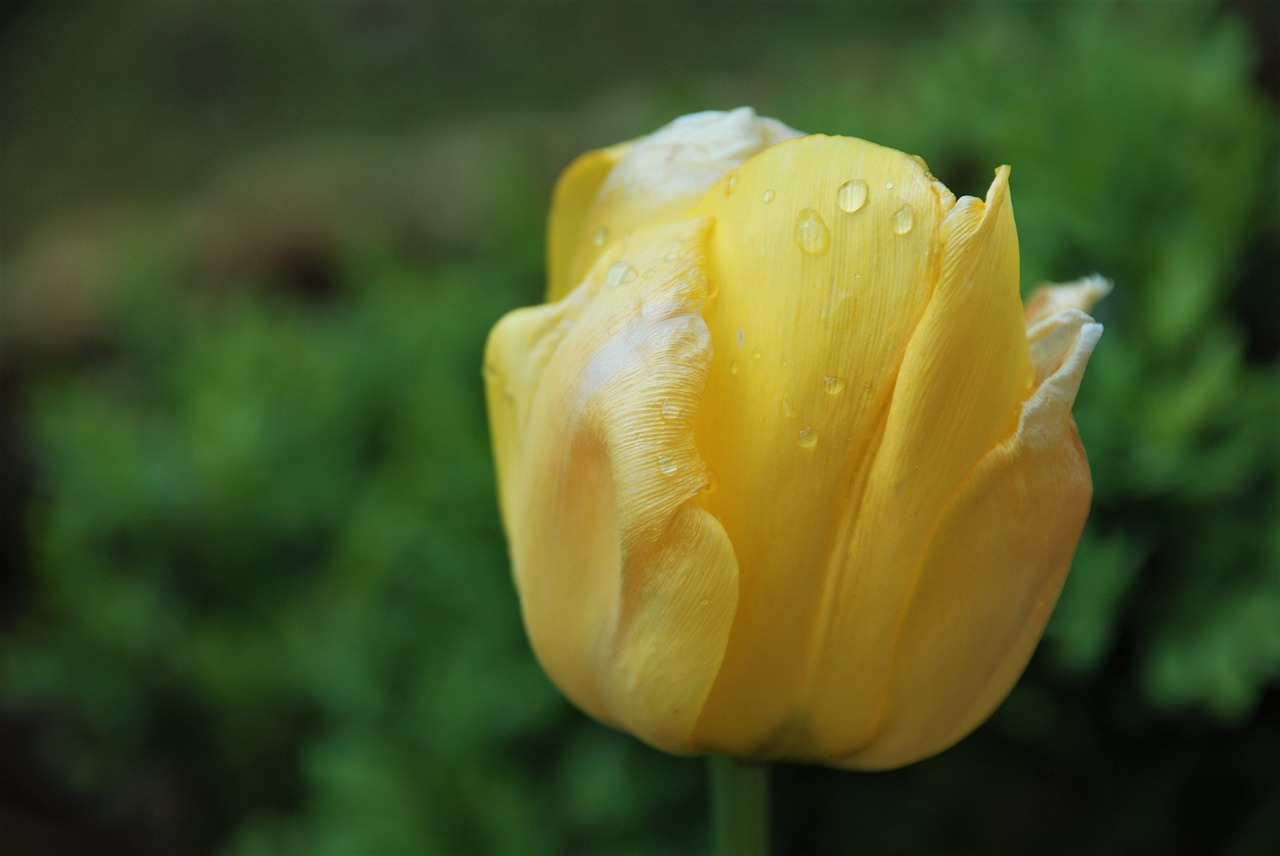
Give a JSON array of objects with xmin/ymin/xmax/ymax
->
[{"xmin": 485, "ymin": 109, "xmax": 1107, "ymax": 769}]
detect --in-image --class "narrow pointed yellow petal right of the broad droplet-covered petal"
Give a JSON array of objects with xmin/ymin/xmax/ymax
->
[{"xmin": 810, "ymin": 168, "xmax": 1032, "ymax": 752}]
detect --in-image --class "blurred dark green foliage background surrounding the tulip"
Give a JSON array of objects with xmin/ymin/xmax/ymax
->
[{"xmin": 0, "ymin": 0, "xmax": 1280, "ymax": 856}]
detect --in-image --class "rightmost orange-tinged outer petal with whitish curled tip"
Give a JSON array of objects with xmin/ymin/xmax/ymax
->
[{"xmin": 842, "ymin": 308, "xmax": 1102, "ymax": 769}]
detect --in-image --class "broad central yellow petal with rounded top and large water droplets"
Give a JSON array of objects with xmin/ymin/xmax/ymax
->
[{"xmin": 695, "ymin": 137, "xmax": 952, "ymax": 755}]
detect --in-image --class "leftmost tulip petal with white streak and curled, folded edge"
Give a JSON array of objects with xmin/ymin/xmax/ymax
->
[{"xmin": 486, "ymin": 220, "xmax": 737, "ymax": 752}]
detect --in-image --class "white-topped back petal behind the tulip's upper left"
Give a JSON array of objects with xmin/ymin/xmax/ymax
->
[{"xmin": 547, "ymin": 107, "xmax": 799, "ymax": 301}]
